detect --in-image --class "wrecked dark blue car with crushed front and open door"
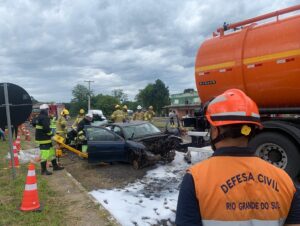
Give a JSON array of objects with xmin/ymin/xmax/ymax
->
[{"xmin": 85, "ymin": 121, "xmax": 182, "ymax": 169}]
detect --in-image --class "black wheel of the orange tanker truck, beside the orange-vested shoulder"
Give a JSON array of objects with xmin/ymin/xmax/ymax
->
[{"xmin": 249, "ymin": 132, "xmax": 300, "ymax": 179}]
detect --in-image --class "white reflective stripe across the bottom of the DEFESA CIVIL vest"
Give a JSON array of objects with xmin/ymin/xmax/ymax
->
[{"xmin": 202, "ymin": 219, "xmax": 285, "ymax": 226}]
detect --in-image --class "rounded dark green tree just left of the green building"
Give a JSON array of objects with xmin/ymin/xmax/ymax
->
[{"xmin": 136, "ymin": 79, "xmax": 170, "ymax": 114}]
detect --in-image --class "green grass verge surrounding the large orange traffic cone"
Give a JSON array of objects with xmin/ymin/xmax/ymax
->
[{"xmin": 0, "ymin": 133, "xmax": 65, "ymax": 226}]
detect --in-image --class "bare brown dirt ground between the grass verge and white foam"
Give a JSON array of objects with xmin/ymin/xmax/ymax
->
[{"xmin": 44, "ymin": 152, "xmax": 155, "ymax": 226}]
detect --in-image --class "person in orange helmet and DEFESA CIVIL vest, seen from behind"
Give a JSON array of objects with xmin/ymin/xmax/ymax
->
[{"xmin": 176, "ymin": 89, "xmax": 300, "ymax": 226}]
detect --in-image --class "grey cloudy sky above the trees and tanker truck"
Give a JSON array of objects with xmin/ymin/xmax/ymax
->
[{"xmin": 0, "ymin": 0, "xmax": 300, "ymax": 102}]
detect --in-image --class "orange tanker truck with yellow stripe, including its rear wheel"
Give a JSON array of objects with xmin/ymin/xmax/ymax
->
[{"xmin": 188, "ymin": 5, "xmax": 300, "ymax": 178}]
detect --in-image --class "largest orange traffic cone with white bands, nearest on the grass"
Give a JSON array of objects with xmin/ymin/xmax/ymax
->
[{"xmin": 20, "ymin": 163, "xmax": 41, "ymax": 211}]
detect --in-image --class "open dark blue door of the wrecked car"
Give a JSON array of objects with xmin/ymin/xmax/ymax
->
[{"xmin": 85, "ymin": 126, "xmax": 128, "ymax": 162}]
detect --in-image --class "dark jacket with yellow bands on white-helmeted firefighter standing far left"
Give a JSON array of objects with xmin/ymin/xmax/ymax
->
[{"xmin": 33, "ymin": 110, "xmax": 53, "ymax": 145}]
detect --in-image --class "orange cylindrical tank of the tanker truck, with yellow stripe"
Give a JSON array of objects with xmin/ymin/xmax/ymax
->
[{"xmin": 195, "ymin": 5, "xmax": 300, "ymax": 108}]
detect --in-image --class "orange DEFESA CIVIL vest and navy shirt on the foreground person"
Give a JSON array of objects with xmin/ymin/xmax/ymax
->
[{"xmin": 176, "ymin": 147, "xmax": 300, "ymax": 226}]
